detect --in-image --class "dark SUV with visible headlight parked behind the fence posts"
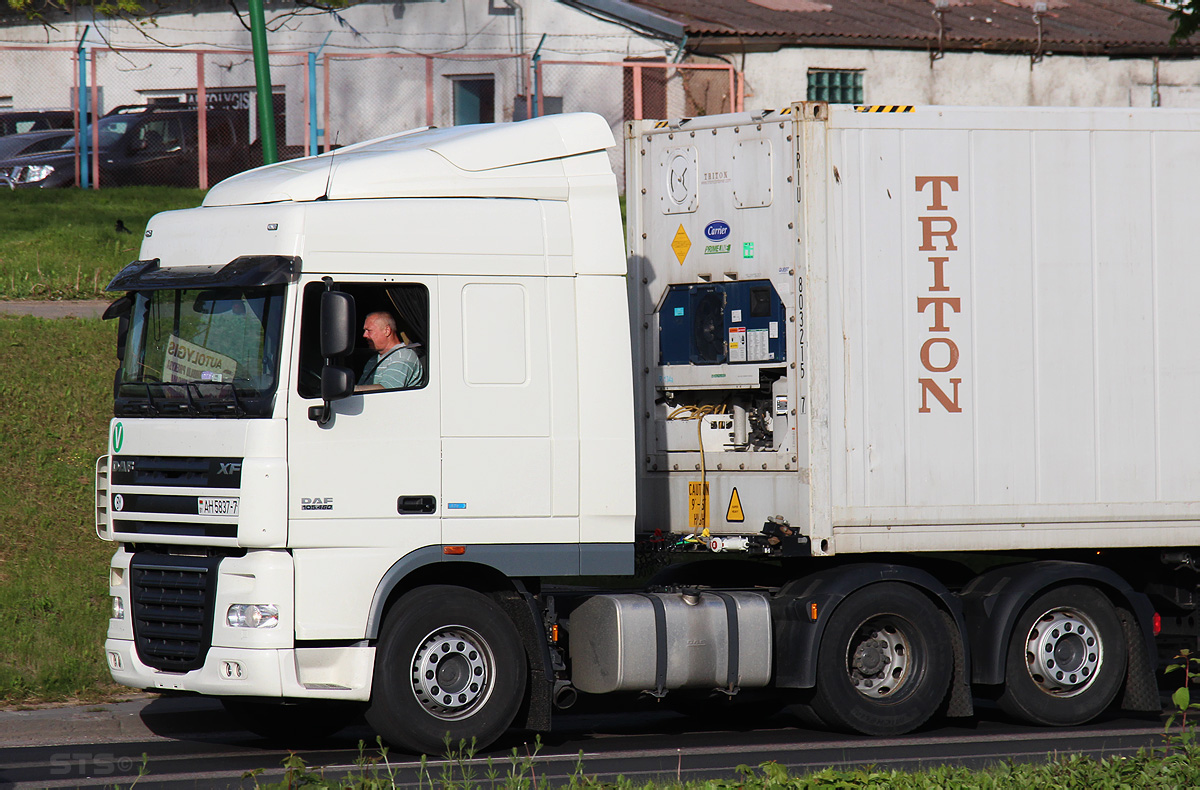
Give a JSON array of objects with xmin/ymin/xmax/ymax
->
[{"xmin": 0, "ymin": 104, "xmax": 250, "ymax": 188}]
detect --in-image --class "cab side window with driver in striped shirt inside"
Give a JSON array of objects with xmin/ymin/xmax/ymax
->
[{"xmin": 296, "ymin": 282, "xmax": 430, "ymax": 397}]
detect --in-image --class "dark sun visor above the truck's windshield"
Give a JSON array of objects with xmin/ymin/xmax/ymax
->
[{"xmin": 104, "ymin": 255, "xmax": 300, "ymax": 291}]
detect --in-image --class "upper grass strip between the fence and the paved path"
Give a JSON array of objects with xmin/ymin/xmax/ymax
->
[{"xmin": 0, "ymin": 186, "xmax": 204, "ymax": 299}]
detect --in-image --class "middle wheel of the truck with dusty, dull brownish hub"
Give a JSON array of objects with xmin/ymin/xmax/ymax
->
[{"xmin": 811, "ymin": 582, "xmax": 954, "ymax": 735}]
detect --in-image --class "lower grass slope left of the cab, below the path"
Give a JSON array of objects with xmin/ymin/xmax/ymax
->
[{"xmin": 0, "ymin": 309, "xmax": 119, "ymax": 704}]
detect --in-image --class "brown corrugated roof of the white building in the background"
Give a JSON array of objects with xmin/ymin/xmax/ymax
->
[{"xmin": 625, "ymin": 0, "xmax": 1200, "ymax": 58}]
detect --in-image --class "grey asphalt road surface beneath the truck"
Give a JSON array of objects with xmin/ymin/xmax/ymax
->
[{"xmin": 0, "ymin": 698, "xmax": 1163, "ymax": 790}]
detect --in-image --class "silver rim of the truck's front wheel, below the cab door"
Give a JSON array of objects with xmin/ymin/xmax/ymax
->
[{"xmin": 413, "ymin": 626, "xmax": 496, "ymax": 722}]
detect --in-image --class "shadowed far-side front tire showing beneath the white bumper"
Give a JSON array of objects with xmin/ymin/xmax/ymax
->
[{"xmin": 221, "ymin": 696, "xmax": 362, "ymax": 747}]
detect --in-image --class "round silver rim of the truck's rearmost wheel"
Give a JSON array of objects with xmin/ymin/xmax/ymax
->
[{"xmin": 1025, "ymin": 609, "xmax": 1104, "ymax": 696}]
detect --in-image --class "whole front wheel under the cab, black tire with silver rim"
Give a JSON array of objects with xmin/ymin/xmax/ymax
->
[{"xmin": 367, "ymin": 585, "xmax": 527, "ymax": 756}]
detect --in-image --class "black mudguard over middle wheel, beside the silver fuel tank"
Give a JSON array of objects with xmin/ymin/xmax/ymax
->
[{"xmin": 772, "ymin": 563, "xmax": 973, "ymax": 717}]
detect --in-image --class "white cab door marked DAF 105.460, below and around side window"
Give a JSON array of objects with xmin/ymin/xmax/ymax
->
[{"xmin": 288, "ymin": 279, "xmax": 442, "ymax": 639}]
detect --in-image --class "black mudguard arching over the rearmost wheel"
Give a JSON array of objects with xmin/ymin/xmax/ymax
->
[{"xmin": 959, "ymin": 559, "xmax": 1160, "ymax": 711}]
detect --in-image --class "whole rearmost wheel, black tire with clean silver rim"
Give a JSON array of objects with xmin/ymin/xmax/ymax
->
[{"xmin": 997, "ymin": 585, "xmax": 1129, "ymax": 726}]
